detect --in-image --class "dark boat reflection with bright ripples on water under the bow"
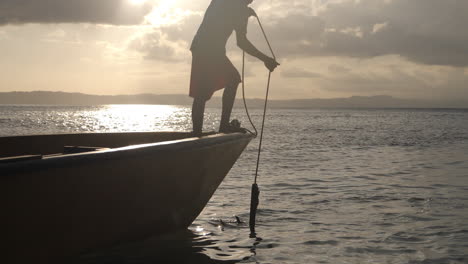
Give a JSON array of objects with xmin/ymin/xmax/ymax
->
[{"xmin": 71, "ymin": 225, "xmax": 262, "ymax": 264}]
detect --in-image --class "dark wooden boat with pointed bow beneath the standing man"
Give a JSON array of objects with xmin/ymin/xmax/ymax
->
[{"xmin": 0, "ymin": 132, "xmax": 252, "ymax": 263}]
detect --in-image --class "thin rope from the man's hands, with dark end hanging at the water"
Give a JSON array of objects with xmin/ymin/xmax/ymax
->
[{"xmin": 242, "ymin": 14, "xmax": 276, "ymax": 237}]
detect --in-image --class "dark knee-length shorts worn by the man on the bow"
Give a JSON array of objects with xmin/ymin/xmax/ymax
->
[{"xmin": 189, "ymin": 52, "xmax": 241, "ymax": 100}]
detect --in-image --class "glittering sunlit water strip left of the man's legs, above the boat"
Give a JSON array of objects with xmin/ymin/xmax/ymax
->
[{"xmin": 0, "ymin": 105, "xmax": 192, "ymax": 136}]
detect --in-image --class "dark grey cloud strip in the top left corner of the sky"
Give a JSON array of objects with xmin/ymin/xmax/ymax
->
[{"xmin": 0, "ymin": 0, "xmax": 152, "ymax": 25}]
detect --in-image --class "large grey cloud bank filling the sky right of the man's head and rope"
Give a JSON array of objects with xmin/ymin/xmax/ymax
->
[{"xmin": 260, "ymin": 0, "xmax": 468, "ymax": 67}]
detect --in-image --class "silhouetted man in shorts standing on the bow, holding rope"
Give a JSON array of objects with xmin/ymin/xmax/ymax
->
[{"xmin": 190, "ymin": 0, "xmax": 279, "ymax": 135}]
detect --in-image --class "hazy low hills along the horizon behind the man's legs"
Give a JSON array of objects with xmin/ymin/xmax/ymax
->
[{"xmin": 0, "ymin": 91, "xmax": 468, "ymax": 108}]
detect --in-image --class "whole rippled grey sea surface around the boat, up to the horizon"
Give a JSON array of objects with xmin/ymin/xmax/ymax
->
[{"xmin": 0, "ymin": 105, "xmax": 468, "ymax": 264}]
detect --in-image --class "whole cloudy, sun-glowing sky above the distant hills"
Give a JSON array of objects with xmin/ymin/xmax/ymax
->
[{"xmin": 0, "ymin": 0, "xmax": 468, "ymax": 101}]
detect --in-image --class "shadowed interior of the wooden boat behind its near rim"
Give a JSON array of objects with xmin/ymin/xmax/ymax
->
[{"xmin": 0, "ymin": 132, "xmax": 210, "ymax": 164}]
